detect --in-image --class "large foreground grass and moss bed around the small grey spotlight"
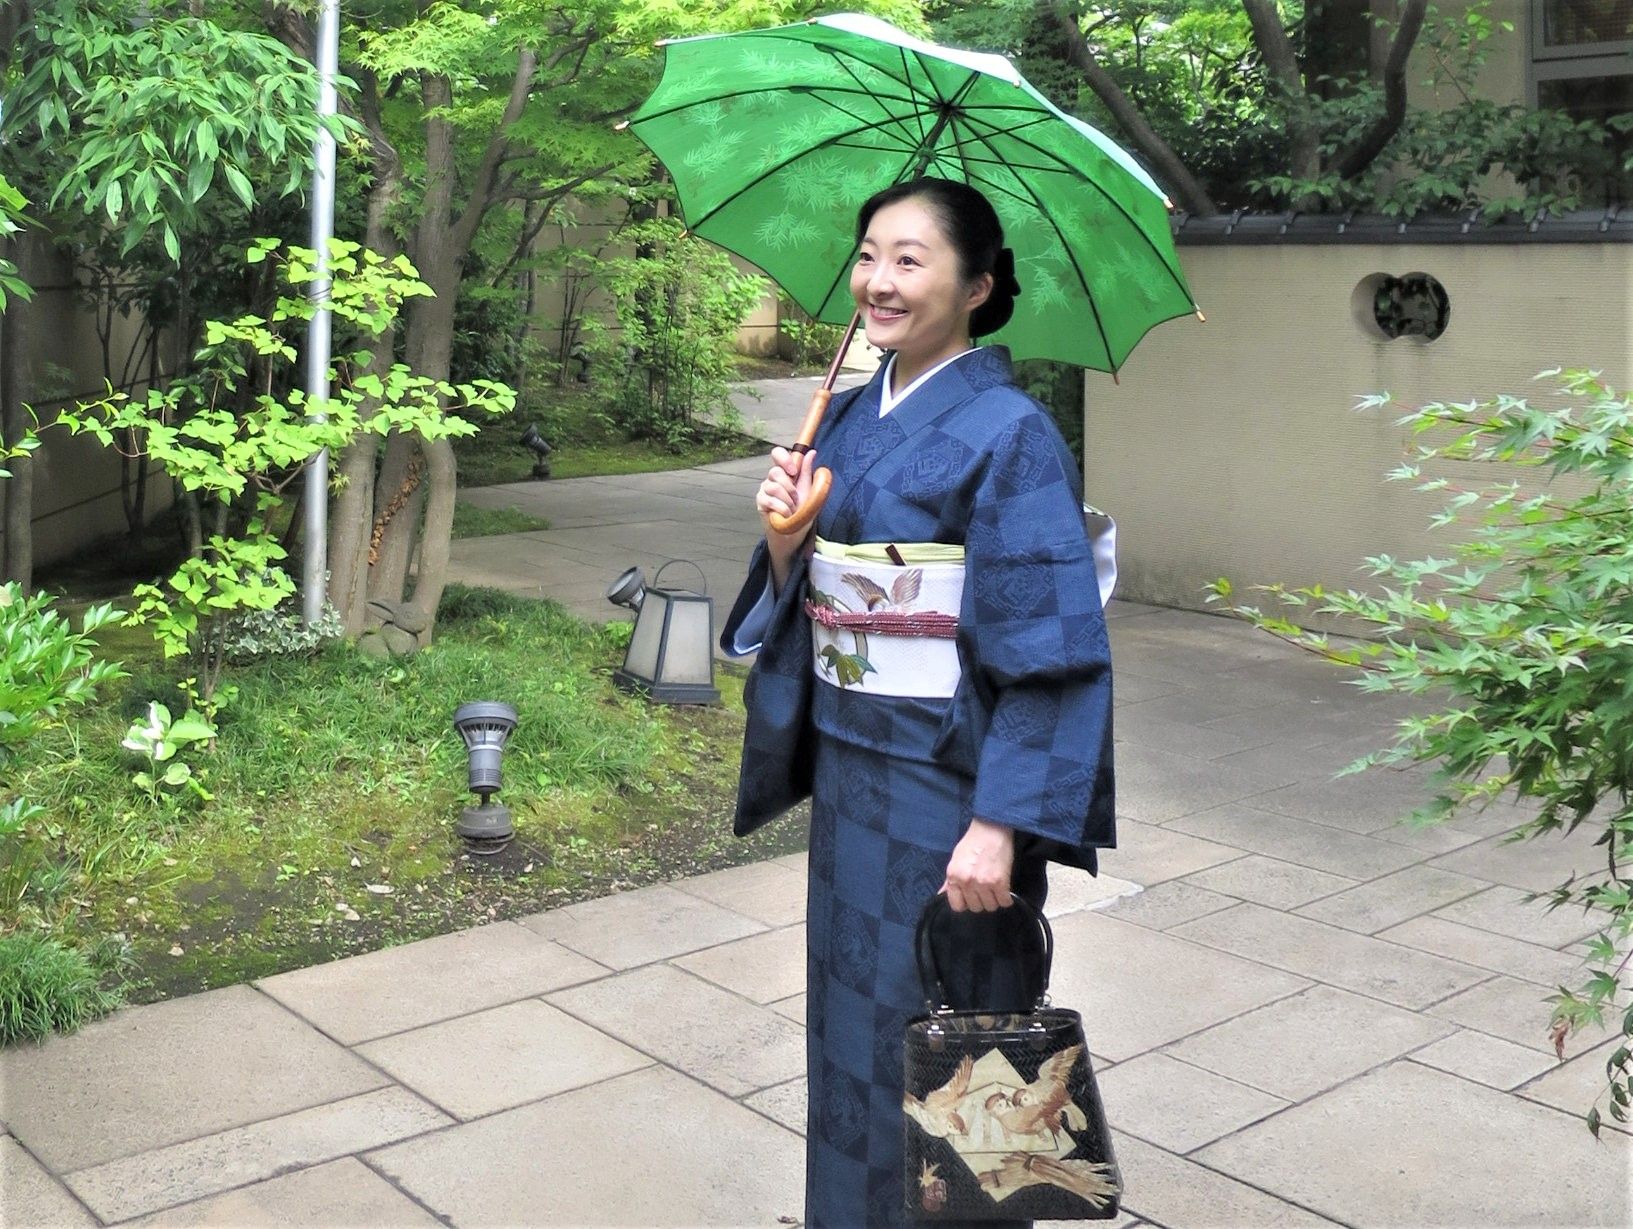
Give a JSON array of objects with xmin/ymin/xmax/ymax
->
[{"xmin": 7, "ymin": 586, "xmax": 805, "ymax": 1002}]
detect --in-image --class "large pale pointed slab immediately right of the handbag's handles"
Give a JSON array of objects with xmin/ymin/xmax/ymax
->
[{"xmin": 1050, "ymin": 912, "xmax": 1310, "ymax": 1063}]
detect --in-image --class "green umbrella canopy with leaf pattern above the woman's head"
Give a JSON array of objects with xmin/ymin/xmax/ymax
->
[{"xmin": 629, "ymin": 13, "xmax": 1197, "ymax": 372}]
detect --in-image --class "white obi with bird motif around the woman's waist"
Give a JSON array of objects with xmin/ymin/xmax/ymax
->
[{"xmin": 805, "ymin": 539, "xmax": 963, "ymax": 700}]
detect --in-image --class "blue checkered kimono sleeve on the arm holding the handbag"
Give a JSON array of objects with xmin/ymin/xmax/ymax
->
[{"xmin": 963, "ymin": 413, "xmax": 1115, "ymax": 865}]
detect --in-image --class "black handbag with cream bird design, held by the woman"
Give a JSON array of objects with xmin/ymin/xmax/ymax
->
[{"xmin": 901, "ymin": 894, "xmax": 1122, "ymax": 1221}]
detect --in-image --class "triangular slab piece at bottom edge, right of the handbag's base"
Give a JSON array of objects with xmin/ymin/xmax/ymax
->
[{"xmin": 1112, "ymin": 1129, "xmax": 1333, "ymax": 1229}]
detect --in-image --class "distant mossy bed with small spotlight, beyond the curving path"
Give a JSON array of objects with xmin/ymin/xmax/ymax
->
[{"xmin": 454, "ymin": 387, "xmax": 764, "ymax": 486}]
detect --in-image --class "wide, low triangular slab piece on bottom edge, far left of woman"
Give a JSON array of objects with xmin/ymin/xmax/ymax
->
[{"xmin": 129, "ymin": 1157, "xmax": 438, "ymax": 1229}]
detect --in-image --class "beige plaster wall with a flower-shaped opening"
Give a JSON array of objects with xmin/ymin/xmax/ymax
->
[{"xmin": 1084, "ymin": 243, "xmax": 1633, "ymax": 609}]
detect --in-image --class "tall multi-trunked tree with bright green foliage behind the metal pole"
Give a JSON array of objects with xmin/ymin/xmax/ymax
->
[{"xmin": 254, "ymin": 0, "xmax": 919, "ymax": 635}]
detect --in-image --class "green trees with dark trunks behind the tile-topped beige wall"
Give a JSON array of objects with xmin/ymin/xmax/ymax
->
[{"xmin": 931, "ymin": 0, "xmax": 1633, "ymax": 215}]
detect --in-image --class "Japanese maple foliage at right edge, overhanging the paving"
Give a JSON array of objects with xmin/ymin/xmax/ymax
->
[{"xmin": 1213, "ymin": 370, "xmax": 1633, "ymax": 1134}]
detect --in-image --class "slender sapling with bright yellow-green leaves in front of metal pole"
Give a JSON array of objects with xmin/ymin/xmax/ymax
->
[{"xmin": 59, "ymin": 240, "xmax": 514, "ymax": 705}]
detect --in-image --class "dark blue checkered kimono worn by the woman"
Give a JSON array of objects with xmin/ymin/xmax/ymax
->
[{"xmin": 722, "ymin": 348, "xmax": 1115, "ymax": 1229}]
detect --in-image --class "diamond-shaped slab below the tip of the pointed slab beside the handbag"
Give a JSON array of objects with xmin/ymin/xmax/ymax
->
[{"xmin": 1164, "ymin": 986, "xmax": 1455, "ymax": 1102}]
